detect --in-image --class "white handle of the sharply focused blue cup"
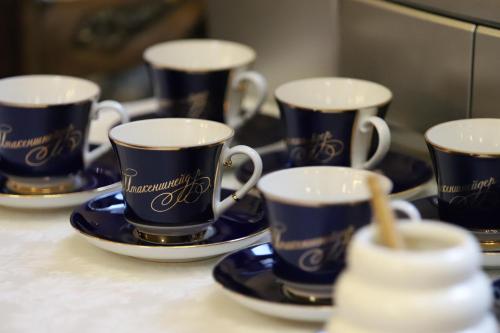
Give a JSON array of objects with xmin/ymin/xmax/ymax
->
[{"xmin": 214, "ymin": 145, "xmax": 262, "ymax": 218}]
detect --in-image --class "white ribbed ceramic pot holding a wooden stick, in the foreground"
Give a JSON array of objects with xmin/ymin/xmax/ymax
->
[{"xmin": 327, "ymin": 221, "xmax": 498, "ymax": 333}]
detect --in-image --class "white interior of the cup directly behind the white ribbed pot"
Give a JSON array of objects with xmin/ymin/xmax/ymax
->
[{"xmin": 258, "ymin": 166, "xmax": 392, "ymax": 206}]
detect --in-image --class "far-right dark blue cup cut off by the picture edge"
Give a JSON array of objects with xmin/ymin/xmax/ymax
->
[{"xmin": 425, "ymin": 118, "xmax": 500, "ymax": 231}]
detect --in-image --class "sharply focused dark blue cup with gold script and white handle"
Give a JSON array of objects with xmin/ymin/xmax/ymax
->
[{"xmin": 109, "ymin": 118, "xmax": 262, "ymax": 243}]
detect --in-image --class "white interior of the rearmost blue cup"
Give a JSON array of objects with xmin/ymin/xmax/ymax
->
[{"xmin": 144, "ymin": 39, "xmax": 255, "ymax": 71}]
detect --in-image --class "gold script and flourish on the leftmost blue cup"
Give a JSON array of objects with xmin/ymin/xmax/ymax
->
[{"xmin": 0, "ymin": 124, "xmax": 83, "ymax": 166}]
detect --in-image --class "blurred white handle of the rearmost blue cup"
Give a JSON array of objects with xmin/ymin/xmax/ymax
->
[{"xmin": 226, "ymin": 71, "xmax": 267, "ymax": 129}]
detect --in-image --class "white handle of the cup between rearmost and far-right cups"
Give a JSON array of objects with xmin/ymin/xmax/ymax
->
[{"xmin": 359, "ymin": 116, "xmax": 391, "ymax": 169}]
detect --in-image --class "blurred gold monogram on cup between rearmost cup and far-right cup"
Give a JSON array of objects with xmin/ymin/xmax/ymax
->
[{"xmin": 287, "ymin": 131, "xmax": 344, "ymax": 163}]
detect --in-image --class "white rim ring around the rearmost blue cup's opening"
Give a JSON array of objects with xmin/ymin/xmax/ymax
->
[{"xmin": 142, "ymin": 38, "xmax": 256, "ymax": 73}]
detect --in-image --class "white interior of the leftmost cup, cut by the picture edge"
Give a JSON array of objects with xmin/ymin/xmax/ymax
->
[{"xmin": 0, "ymin": 75, "xmax": 99, "ymax": 107}]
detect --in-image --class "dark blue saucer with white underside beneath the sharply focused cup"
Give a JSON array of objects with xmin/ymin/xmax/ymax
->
[{"xmin": 71, "ymin": 190, "xmax": 269, "ymax": 262}]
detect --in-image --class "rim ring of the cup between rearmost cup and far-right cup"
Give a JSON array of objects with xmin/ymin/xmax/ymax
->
[{"xmin": 274, "ymin": 76, "xmax": 393, "ymax": 113}]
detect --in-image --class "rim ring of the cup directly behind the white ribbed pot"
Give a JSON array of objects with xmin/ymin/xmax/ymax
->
[{"xmin": 257, "ymin": 166, "xmax": 393, "ymax": 207}]
